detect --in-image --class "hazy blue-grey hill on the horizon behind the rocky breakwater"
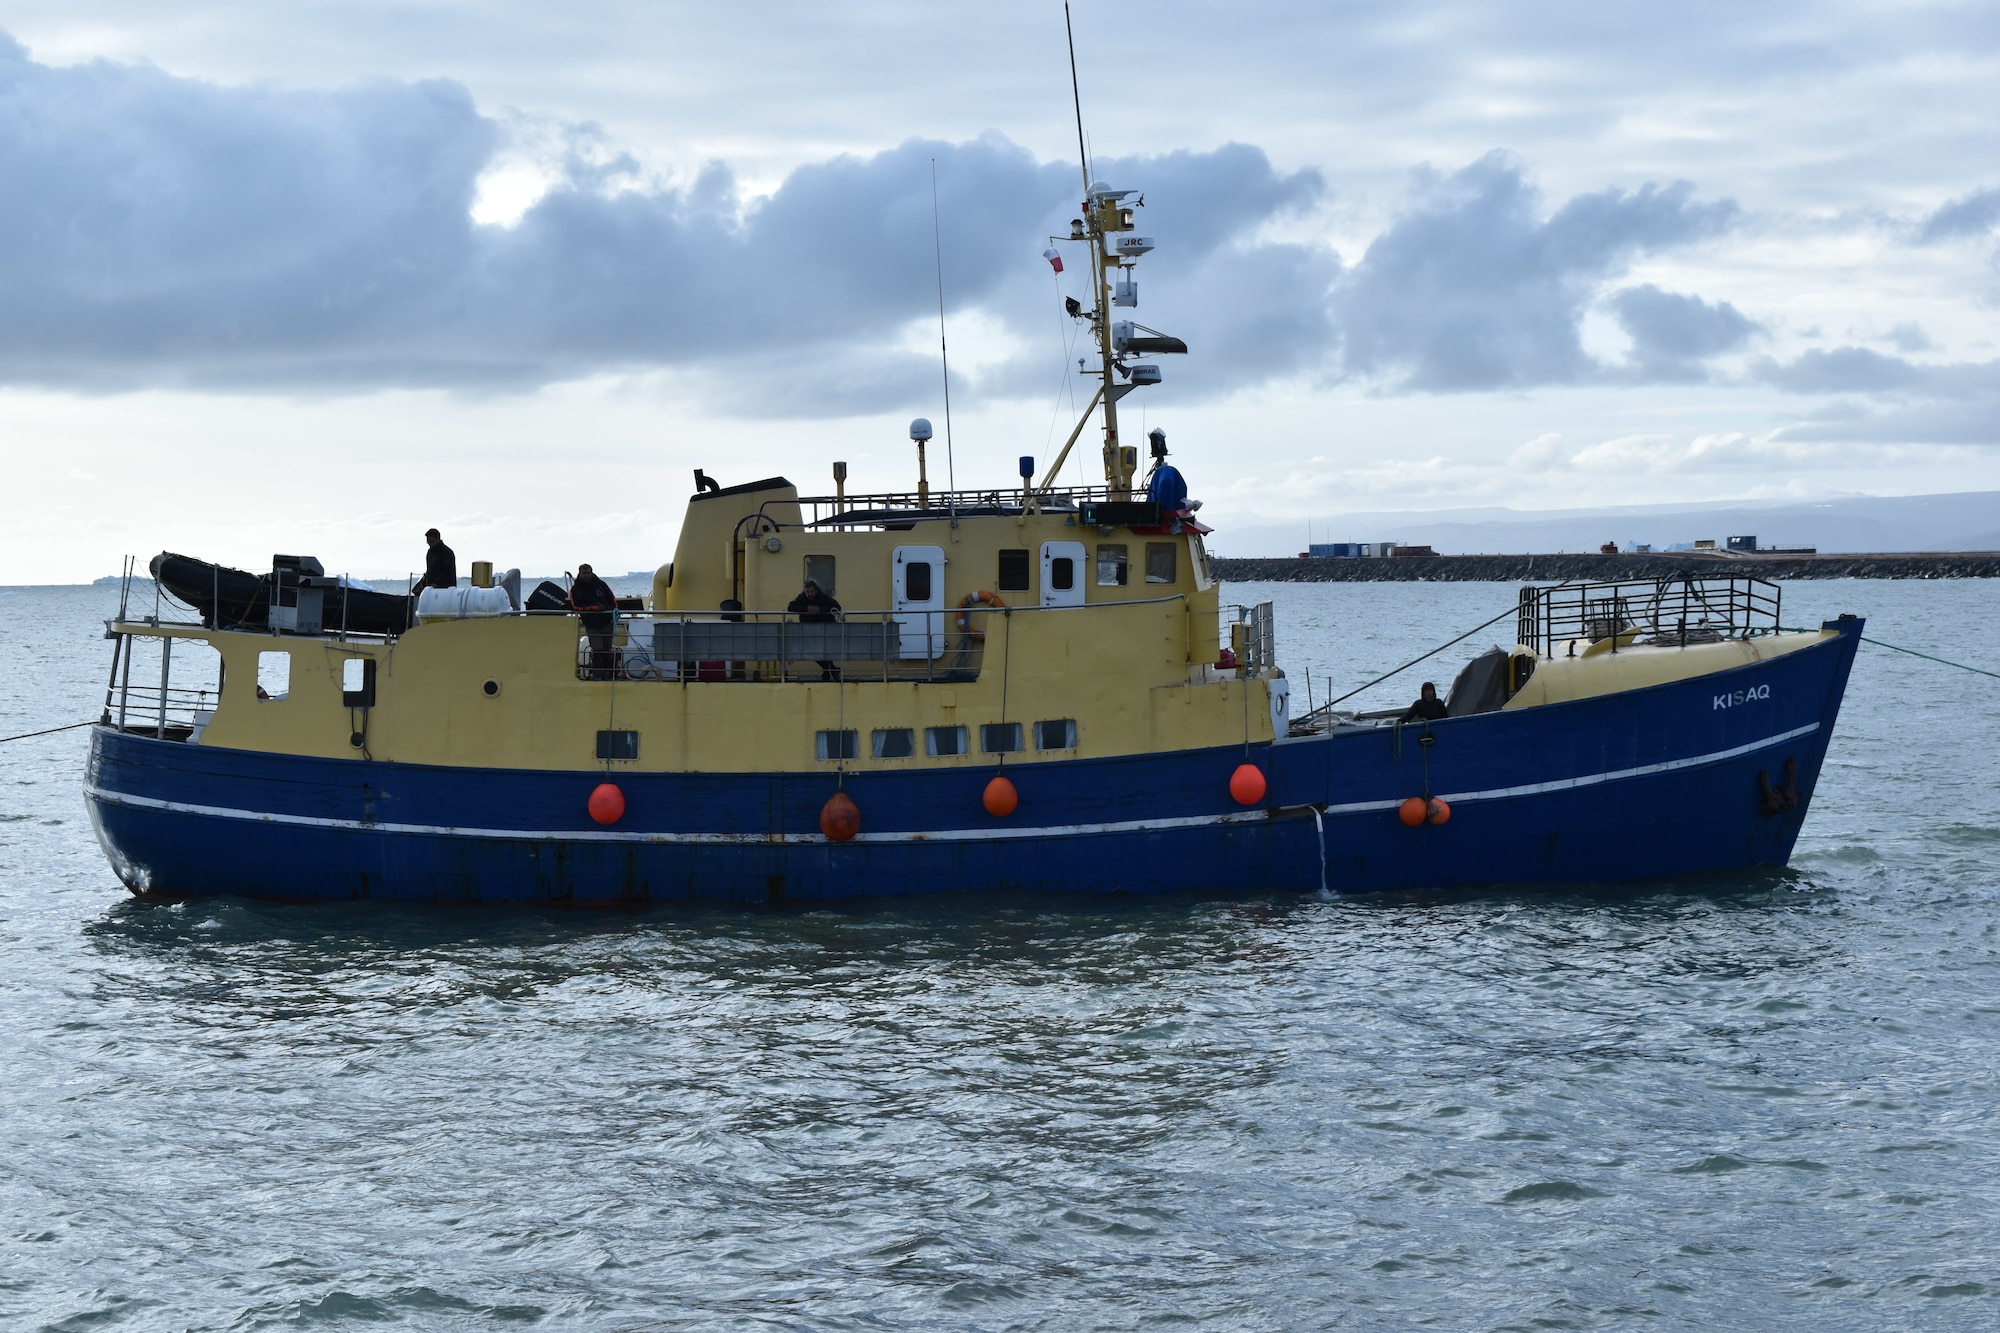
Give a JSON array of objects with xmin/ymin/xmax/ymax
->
[{"xmin": 1208, "ymin": 490, "xmax": 2000, "ymax": 556}]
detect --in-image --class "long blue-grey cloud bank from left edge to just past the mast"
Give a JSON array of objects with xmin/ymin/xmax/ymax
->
[{"xmin": 0, "ymin": 34, "xmax": 1330, "ymax": 412}]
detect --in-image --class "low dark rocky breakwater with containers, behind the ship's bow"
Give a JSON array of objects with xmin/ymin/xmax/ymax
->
[{"xmin": 1216, "ymin": 550, "xmax": 2000, "ymax": 582}]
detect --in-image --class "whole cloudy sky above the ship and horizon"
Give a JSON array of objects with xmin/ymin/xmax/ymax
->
[{"xmin": 0, "ymin": 0, "xmax": 2000, "ymax": 582}]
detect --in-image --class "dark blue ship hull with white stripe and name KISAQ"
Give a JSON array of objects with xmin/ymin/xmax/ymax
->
[{"xmin": 86, "ymin": 620, "xmax": 1862, "ymax": 907}]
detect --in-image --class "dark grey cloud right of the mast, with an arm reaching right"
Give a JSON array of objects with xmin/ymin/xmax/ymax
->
[{"xmin": 1336, "ymin": 152, "xmax": 1738, "ymax": 392}]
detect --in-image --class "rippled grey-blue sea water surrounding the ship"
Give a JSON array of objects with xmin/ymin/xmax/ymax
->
[{"xmin": 0, "ymin": 582, "xmax": 2000, "ymax": 1331}]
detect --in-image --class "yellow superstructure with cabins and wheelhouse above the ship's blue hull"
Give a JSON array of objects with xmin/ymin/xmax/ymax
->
[{"xmin": 114, "ymin": 478, "xmax": 1282, "ymax": 773}]
